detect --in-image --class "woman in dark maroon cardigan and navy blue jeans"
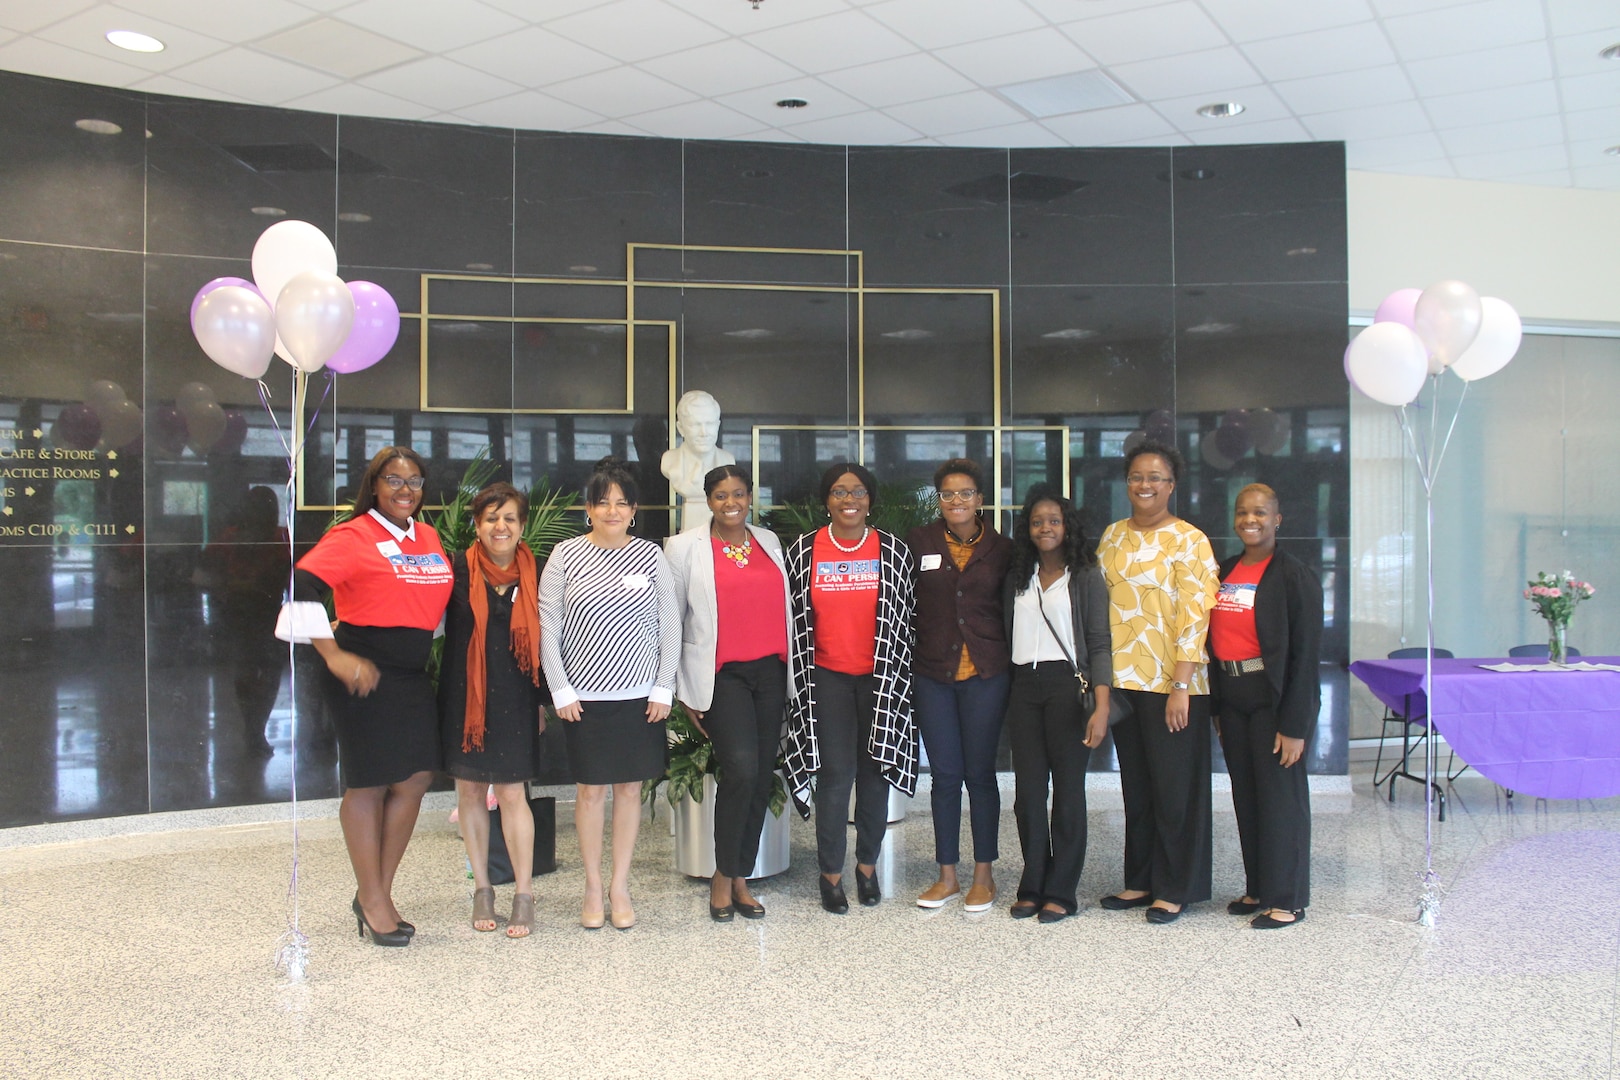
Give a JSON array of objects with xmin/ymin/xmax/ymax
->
[{"xmin": 906, "ymin": 458, "xmax": 1013, "ymax": 912}]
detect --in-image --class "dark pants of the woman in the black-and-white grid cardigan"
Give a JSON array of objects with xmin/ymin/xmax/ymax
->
[{"xmin": 815, "ymin": 667, "xmax": 889, "ymax": 874}]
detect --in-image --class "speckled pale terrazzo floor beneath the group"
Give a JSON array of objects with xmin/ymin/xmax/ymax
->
[{"xmin": 0, "ymin": 769, "xmax": 1620, "ymax": 1078}]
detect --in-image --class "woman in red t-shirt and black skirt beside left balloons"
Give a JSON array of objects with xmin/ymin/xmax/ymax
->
[{"xmin": 275, "ymin": 447, "xmax": 454, "ymax": 946}]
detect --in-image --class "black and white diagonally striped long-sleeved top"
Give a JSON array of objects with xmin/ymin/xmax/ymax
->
[{"xmin": 539, "ymin": 536, "xmax": 680, "ymax": 708}]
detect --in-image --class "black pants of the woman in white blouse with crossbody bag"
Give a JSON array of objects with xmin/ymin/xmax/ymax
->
[{"xmin": 1008, "ymin": 662, "xmax": 1092, "ymax": 915}]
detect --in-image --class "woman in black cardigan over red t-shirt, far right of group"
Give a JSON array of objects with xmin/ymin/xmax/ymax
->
[{"xmin": 1209, "ymin": 484, "xmax": 1322, "ymax": 929}]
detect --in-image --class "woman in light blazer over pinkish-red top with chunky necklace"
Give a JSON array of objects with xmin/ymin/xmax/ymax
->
[{"xmin": 664, "ymin": 465, "xmax": 792, "ymax": 923}]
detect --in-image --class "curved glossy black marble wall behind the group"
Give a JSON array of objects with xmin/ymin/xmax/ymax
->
[{"xmin": 0, "ymin": 73, "xmax": 1349, "ymax": 826}]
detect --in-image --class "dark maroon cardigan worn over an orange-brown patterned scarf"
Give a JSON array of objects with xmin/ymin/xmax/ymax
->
[{"xmin": 906, "ymin": 521, "xmax": 1013, "ymax": 683}]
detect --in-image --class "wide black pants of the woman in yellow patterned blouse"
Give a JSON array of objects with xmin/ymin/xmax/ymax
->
[{"xmin": 1111, "ymin": 688, "xmax": 1213, "ymax": 904}]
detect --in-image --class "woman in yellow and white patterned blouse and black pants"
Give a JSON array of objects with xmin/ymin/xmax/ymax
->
[{"xmin": 1097, "ymin": 442, "xmax": 1220, "ymax": 923}]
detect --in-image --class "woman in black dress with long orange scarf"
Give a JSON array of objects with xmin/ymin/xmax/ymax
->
[{"xmin": 439, "ymin": 483, "xmax": 546, "ymax": 938}]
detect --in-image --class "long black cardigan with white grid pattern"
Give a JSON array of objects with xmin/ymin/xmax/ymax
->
[{"xmin": 782, "ymin": 529, "xmax": 917, "ymax": 818}]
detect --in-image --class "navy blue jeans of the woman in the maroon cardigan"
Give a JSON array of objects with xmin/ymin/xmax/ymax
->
[{"xmin": 912, "ymin": 672, "xmax": 1011, "ymax": 866}]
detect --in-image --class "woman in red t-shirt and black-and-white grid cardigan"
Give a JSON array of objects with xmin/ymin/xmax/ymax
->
[{"xmin": 786, "ymin": 463, "xmax": 917, "ymax": 915}]
